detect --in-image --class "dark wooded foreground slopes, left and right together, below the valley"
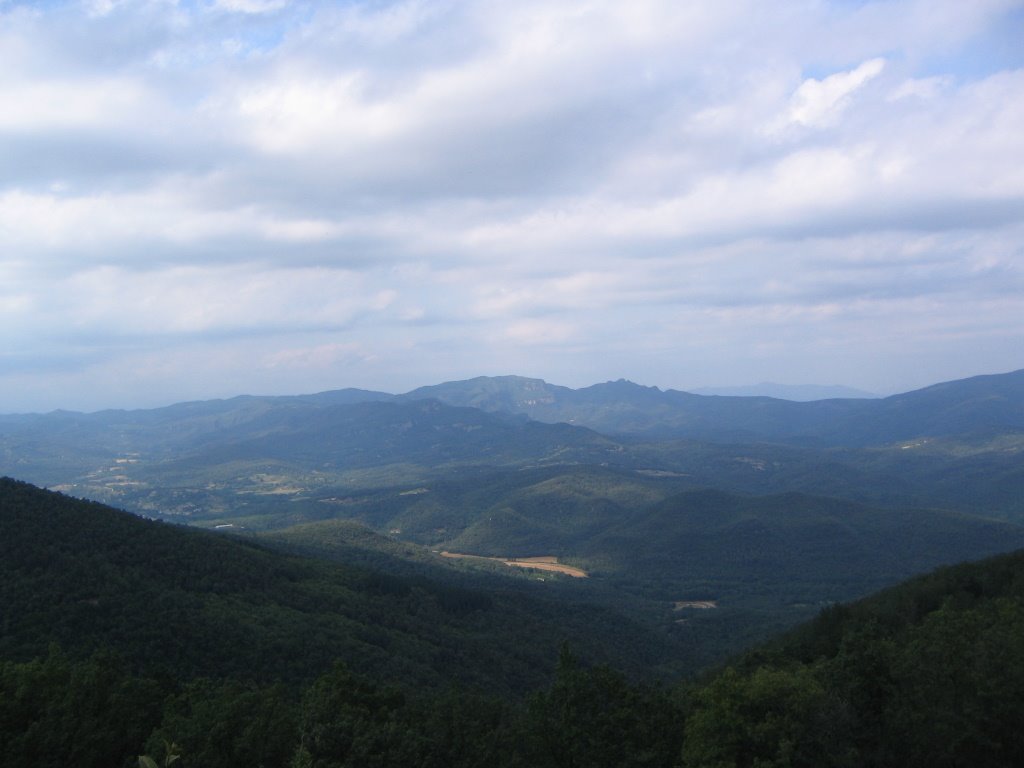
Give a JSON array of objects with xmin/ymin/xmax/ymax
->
[{"xmin": 0, "ymin": 480, "xmax": 1024, "ymax": 768}]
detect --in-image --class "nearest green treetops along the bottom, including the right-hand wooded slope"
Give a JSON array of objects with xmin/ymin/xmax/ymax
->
[{"xmin": 6, "ymin": 553, "xmax": 1024, "ymax": 768}]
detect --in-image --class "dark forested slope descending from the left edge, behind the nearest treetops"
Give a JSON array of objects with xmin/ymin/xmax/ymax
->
[{"xmin": 0, "ymin": 479, "xmax": 684, "ymax": 691}]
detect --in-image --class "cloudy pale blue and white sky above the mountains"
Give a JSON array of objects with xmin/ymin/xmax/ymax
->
[{"xmin": 0, "ymin": 0, "xmax": 1024, "ymax": 413}]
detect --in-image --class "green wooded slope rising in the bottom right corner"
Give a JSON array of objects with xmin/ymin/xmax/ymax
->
[{"xmin": 683, "ymin": 553, "xmax": 1024, "ymax": 768}]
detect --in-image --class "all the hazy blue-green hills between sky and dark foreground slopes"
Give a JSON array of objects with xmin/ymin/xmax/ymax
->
[{"xmin": 0, "ymin": 371, "xmax": 1024, "ymax": 664}]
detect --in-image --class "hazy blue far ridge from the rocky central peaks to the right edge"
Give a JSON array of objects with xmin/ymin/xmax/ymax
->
[{"xmin": 399, "ymin": 370, "xmax": 1024, "ymax": 446}]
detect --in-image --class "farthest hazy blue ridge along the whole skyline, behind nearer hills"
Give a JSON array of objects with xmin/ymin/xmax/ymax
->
[{"xmin": 8, "ymin": 370, "xmax": 1024, "ymax": 448}]
